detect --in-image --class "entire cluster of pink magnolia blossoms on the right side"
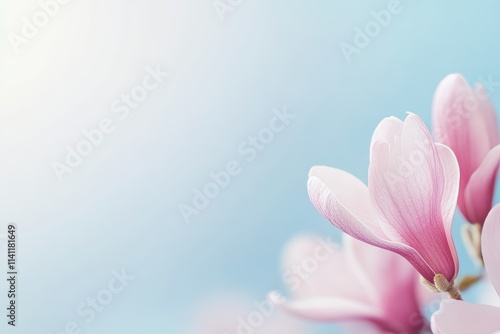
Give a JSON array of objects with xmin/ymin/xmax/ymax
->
[{"xmin": 271, "ymin": 74, "xmax": 500, "ymax": 334}]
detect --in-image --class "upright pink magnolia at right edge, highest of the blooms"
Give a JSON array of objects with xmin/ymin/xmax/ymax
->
[{"xmin": 432, "ymin": 74, "xmax": 500, "ymax": 224}]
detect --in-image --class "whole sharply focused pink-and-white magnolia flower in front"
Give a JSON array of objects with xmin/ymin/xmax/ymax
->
[{"xmin": 307, "ymin": 114, "xmax": 460, "ymax": 292}]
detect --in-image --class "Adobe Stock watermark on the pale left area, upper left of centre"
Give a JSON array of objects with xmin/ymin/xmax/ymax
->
[{"xmin": 52, "ymin": 65, "xmax": 169, "ymax": 183}]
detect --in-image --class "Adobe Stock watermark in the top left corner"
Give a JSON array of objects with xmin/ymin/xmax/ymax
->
[{"xmin": 7, "ymin": 0, "xmax": 71, "ymax": 53}]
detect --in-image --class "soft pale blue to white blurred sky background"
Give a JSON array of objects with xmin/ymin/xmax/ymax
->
[{"xmin": 0, "ymin": 0, "xmax": 500, "ymax": 334}]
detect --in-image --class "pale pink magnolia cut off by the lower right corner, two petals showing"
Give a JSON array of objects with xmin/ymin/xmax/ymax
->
[{"xmin": 432, "ymin": 204, "xmax": 500, "ymax": 334}]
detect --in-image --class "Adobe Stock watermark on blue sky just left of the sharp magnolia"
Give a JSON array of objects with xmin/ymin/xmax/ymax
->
[{"xmin": 178, "ymin": 107, "xmax": 296, "ymax": 224}]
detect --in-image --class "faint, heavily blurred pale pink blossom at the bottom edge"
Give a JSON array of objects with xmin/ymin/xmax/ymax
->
[{"xmin": 189, "ymin": 297, "xmax": 305, "ymax": 334}]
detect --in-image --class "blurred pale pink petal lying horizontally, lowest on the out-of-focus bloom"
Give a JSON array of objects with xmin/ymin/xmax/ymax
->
[{"xmin": 268, "ymin": 292, "xmax": 382, "ymax": 321}]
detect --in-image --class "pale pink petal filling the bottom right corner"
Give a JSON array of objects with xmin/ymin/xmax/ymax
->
[{"xmin": 432, "ymin": 300, "xmax": 500, "ymax": 334}]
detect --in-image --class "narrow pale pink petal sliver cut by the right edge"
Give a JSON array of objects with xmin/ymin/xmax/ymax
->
[{"xmin": 481, "ymin": 204, "xmax": 500, "ymax": 294}]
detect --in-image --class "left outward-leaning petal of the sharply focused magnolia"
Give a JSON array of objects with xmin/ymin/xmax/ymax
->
[{"xmin": 307, "ymin": 167, "xmax": 435, "ymax": 281}]
